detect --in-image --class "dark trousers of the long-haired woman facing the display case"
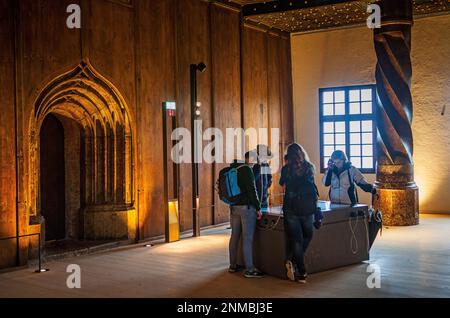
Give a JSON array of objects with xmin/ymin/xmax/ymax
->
[{"xmin": 284, "ymin": 211, "xmax": 314, "ymax": 275}]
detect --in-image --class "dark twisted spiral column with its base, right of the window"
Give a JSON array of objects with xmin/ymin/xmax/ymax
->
[{"xmin": 374, "ymin": 0, "xmax": 419, "ymax": 225}]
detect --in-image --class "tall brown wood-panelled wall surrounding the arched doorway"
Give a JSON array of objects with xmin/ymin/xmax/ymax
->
[{"xmin": 0, "ymin": 0, "xmax": 293, "ymax": 267}]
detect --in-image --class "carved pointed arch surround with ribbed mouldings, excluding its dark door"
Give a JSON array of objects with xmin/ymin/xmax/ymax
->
[{"xmin": 29, "ymin": 62, "xmax": 136, "ymax": 239}]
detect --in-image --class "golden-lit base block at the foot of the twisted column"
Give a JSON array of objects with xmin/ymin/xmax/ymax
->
[{"xmin": 374, "ymin": 185, "xmax": 420, "ymax": 226}]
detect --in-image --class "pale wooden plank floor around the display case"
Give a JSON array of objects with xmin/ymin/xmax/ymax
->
[{"xmin": 0, "ymin": 215, "xmax": 450, "ymax": 298}]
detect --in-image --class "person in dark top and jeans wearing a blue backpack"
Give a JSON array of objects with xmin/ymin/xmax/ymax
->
[{"xmin": 219, "ymin": 153, "xmax": 264, "ymax": 278}]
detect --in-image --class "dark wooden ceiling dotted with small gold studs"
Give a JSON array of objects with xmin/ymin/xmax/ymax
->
[{"xmin": 231, "ymin": 0, "xmax": 450, "ymax": 32}]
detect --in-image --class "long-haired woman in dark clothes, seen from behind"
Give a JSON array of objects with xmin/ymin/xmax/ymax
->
[{"xmin": 280, "ymin": 143, "xmax": 318, "ymax": 284}]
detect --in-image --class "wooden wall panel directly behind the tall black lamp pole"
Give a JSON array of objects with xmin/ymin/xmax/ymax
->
[{"xmin": 175, "ymin": 0, "xmax": 213, "ymax": 231}]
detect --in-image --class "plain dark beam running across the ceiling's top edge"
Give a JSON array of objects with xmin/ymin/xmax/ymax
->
[{"xmin": 242, "ymin": 0, "xmax": 356, "ymax": 17}]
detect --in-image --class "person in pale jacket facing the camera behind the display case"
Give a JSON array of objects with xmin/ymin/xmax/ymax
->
[{"xmin": 322, "ymin": 150, "xmax": 377, "ymax": 205}]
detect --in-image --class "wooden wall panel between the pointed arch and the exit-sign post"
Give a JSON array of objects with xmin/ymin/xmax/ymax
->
[{"xmin": 136, "ymin": 0, "xmax": 178, "ymax": 238}]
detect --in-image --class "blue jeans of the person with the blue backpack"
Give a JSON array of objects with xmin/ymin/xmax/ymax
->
[{"xmin": 230, "ymin": 205, "xmax": 256, "ymax": 272}]
